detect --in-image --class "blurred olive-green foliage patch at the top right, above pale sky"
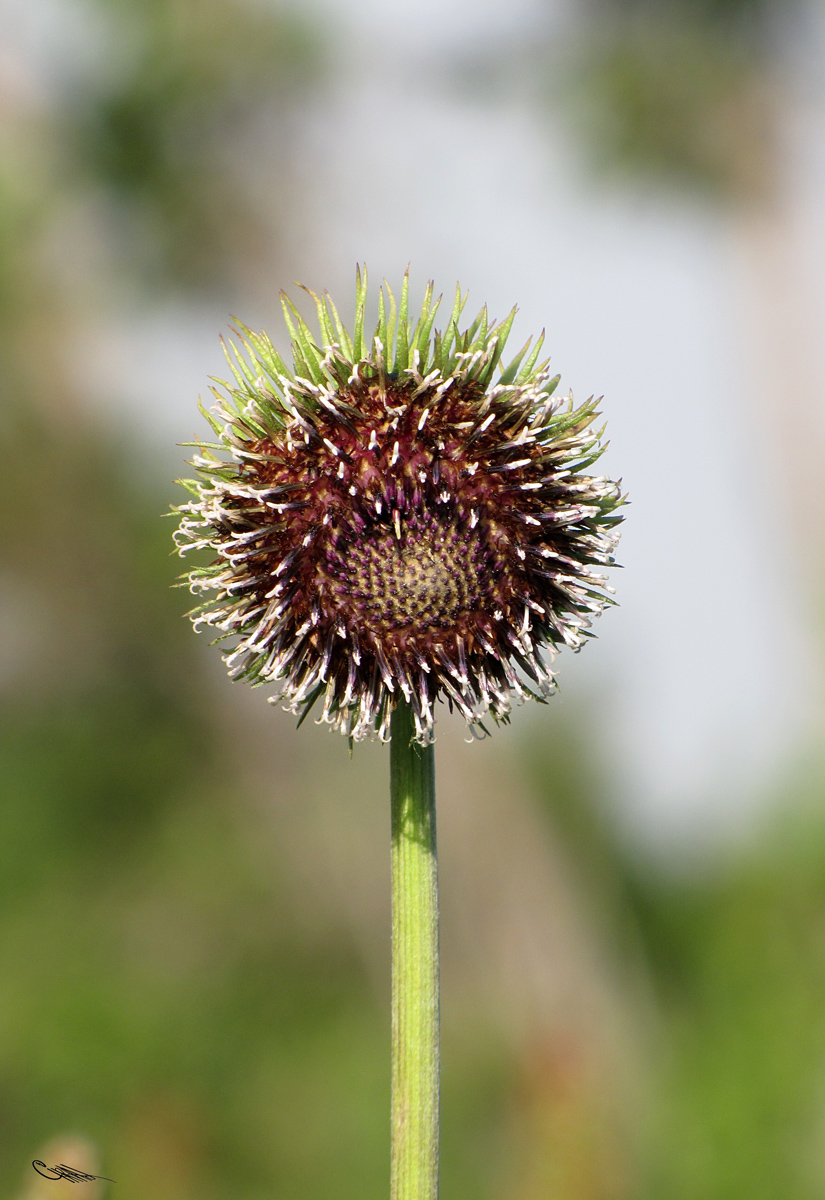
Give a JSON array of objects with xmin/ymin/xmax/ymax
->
[{"xmin": 576, "ymin": 0, "xmax": 793, "ymax": 202}]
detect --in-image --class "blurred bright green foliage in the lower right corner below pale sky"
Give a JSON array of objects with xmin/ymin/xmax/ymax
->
[{"xmin": 528, "ymin": 724, "xmax": 825, "ymax": 1200}]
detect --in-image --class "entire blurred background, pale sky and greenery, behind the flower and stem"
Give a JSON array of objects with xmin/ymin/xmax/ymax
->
[{"xmin": 0, "ymin": 0, "xmax": 825, "ymax": 1200}]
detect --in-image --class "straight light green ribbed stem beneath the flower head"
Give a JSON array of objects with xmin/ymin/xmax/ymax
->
[{"xmin": 390, "ymin": 701, "xmax": 440, "ymax": 1200}]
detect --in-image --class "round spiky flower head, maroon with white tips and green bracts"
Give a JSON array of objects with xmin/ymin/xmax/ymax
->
[{"xmin": 176, "ymin": 271, "xmax": 622, "ymax": 743}]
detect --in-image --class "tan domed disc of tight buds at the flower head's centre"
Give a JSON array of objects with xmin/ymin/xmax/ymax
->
[{"xmin": 342, "ymin": 517, "xmax": 486, "ymax": 631}]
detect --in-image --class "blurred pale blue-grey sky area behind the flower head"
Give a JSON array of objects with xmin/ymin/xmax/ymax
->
[{"xmin": 0, "ymin": 0, "xmax": 825, "ymax": 836}]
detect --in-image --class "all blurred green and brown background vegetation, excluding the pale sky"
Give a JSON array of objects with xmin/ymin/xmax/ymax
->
[{"xmin": 0, "ymin": 0, "xmax": 825, "ymax": 1200}]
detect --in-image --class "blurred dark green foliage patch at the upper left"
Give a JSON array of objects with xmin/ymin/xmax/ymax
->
[{"xmin": 60, "ymin": 0, "xmax": 320, "ymax": 288}]
